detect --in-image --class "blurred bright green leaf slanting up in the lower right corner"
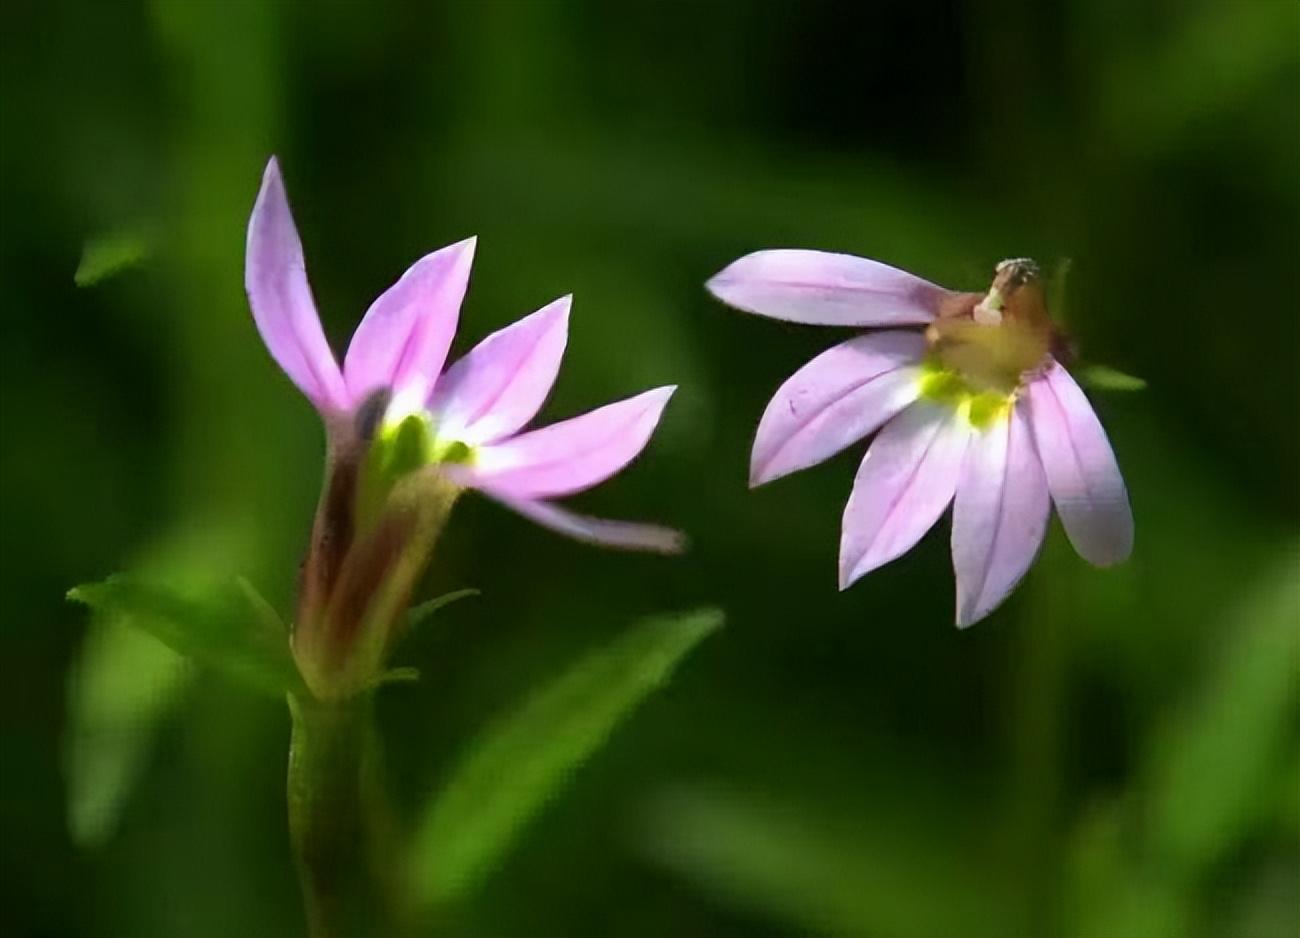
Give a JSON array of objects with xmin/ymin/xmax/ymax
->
[{"xmin": 1067, "ymin": 547, "xmax": 1300, "ymax": 938}]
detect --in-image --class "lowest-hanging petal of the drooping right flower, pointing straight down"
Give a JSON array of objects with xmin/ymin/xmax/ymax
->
[{"xmin": 953, "ymin": 408, "xmax": 1052, "ymax": 627}]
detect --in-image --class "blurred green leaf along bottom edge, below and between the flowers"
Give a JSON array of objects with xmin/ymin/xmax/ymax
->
[{"xmin": 645, "ymin": 787, "xmax": 1017, "ymax": 938}]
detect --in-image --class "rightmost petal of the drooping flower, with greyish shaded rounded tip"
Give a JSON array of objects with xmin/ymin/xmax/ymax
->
[{"xmin": 1028, "ymin": 362, "xmax": 1134, "ymax": 566}]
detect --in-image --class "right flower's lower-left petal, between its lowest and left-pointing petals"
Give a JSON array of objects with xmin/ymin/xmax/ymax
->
[{"xmin": 840, "ymin": 401, "xmax": 970, "ymax": 590}]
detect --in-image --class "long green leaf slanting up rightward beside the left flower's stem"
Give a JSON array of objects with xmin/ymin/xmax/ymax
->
[{"xmin": 412, "ymin": 609, "xmax": 723, "ymax": 904}]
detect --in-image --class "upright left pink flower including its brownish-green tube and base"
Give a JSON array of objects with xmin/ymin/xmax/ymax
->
[{"xmin": 244, "ymin": 158, "xmax": 683, "ymax": 695}]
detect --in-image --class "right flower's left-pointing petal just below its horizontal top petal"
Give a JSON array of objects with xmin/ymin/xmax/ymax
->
[{"xmin": 749, "ymin": 331, "xmax": 926, "ymax": 486}]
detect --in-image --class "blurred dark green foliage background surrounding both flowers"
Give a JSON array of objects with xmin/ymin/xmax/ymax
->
[{"xmin": 0, "ymin": 0, "xmax": 1300, "ymax": 938}]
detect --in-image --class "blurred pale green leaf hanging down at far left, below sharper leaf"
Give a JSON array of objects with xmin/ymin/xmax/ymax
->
[{"xmin": 64, "ymin": 618, "xmax": 191, "ymax": 847}]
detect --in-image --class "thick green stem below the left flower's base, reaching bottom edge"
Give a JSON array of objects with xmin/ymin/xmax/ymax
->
[{"xmin": 287, "ymin": 696, "xmax": 369, "ymax": 938}]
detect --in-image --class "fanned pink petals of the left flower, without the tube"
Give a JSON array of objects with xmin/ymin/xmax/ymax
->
[{"xmin": 244, "ymin": 158, "xmax": 681, "ymax": 552}]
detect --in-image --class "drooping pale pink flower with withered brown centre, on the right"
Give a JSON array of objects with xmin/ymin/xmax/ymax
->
[{"xmin": 709, "ymin": 251, "xmax": 1134, "ymax": 627}]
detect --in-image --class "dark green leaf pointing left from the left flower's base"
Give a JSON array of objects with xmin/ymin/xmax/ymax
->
[{"xmin": 68, "ymin": 574, "xmax": 303, "ymax": 695}]
